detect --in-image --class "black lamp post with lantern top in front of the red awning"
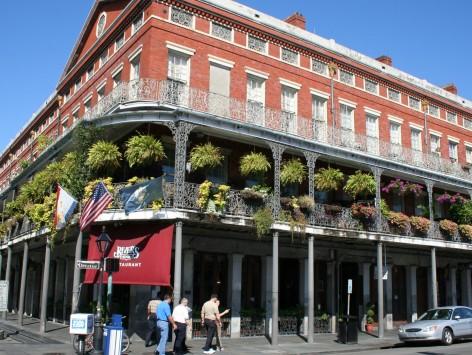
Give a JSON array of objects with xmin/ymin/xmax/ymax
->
[{"xmin": 93, "ymin": 226, "xmax": 111, "ymax": 354}]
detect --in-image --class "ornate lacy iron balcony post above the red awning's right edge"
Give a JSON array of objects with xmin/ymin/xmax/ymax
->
[{"xmin": 166, "ymin": 121, "xmax": 195, "ymax": 208}]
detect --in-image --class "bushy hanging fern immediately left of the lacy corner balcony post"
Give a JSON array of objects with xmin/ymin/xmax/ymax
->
[{"xmin": 125, "ymin": 135, "xmax": 166, "ymax": 168}]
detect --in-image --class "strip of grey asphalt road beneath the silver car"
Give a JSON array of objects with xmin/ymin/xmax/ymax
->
[{"xmin": 353, "ymin": 341, "xmax": 472, "ymax": 355}]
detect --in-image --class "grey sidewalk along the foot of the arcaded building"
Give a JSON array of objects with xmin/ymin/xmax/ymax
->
[{"xmin": 0, "ymin": 314, "xmax": 398, "ymax": 355}]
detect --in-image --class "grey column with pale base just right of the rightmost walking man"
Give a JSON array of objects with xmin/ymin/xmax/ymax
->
[{"xmin": 231, "ymin": 254, "xmax": 243, "ymax": 338}]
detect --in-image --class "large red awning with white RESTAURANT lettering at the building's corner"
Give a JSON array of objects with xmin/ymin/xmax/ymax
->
[{"xmin": 84, "ymin": 225, "xmax": 174, "ymax": 286}]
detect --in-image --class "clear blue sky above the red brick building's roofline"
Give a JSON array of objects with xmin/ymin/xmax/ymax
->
[{"xmin": 0, "ymin": 0, "xmax": 472, "ymax": 151}]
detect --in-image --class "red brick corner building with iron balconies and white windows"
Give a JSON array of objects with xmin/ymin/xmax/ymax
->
[{"xmin": 0, "ymin": 0, "xmax": 472, "ymax": 344}]
